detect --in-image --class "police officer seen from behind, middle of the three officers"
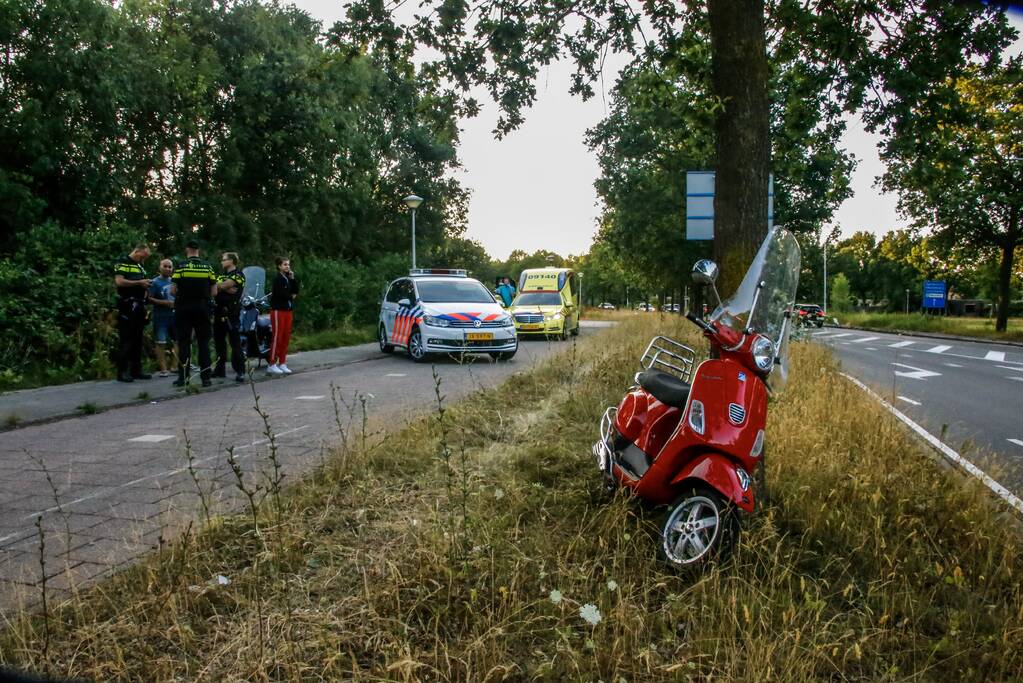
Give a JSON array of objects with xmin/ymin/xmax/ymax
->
[{"xmin": 171, "ymin": 241, "xmax": 217, "ymax": 386}]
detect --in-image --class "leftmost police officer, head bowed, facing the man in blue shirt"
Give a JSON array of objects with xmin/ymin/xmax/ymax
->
[{"xmin": 114, "ymin": 243, "xmax": 152, "ymax": 381}]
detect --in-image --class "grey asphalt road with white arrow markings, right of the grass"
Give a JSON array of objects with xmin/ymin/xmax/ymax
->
[{"xmin": 812, "ymin": 328, "xmax": 1023, "ymax": 496}]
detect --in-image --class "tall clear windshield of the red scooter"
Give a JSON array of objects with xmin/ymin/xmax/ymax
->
[{"xmin": 711, "ymin": 228, "xmax": 800, "ymax": 385}]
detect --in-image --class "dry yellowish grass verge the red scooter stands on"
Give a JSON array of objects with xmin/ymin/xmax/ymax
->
[{"xmin": 0, "ymin": 316, "xmax": 1023, "ymax": 682}]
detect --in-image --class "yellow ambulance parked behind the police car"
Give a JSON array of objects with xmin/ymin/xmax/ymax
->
[{"xmin": 508, "ymin": 268, "xmax": 582, "ymax": 339}]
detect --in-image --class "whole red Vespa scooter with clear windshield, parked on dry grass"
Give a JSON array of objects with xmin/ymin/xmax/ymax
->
[{"xmin": 593, "ymin": 228, "xmax": 800, "ymax": 568}]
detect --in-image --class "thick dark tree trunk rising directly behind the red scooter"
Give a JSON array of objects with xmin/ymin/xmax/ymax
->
[{"xmin": 707, "ymin": 0, "xmax": 770, "ymax": 297}]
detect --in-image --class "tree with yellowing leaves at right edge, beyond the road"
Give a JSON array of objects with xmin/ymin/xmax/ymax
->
[{"xmin": 883, "ymin": 58, "xmax": 1023, "ymax": 331}]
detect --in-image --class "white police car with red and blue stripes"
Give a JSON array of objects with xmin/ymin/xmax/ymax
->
[{"xmin": 376, "ymin": 268, "xmax": 519, "ymax": 362}]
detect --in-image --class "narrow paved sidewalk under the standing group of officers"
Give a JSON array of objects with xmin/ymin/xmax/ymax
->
[{"xmin": 0, "ymin": 344, "xmax": 380, "ymax": 431}]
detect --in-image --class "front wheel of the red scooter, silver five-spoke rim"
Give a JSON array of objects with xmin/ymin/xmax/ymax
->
[{"xmin": 659, "ymin": 487, "xmax": 739, "ymax": 570}]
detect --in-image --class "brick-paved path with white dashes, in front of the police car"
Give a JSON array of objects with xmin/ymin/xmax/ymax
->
[{"xmin": 0, "ymin": 322, "xmax": 611, "ymax": 612}]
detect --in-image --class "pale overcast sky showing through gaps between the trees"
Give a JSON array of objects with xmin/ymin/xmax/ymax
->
[{"xmin": 295, "ymin": 0, "xmax": 1023, "ymax": 259}]
